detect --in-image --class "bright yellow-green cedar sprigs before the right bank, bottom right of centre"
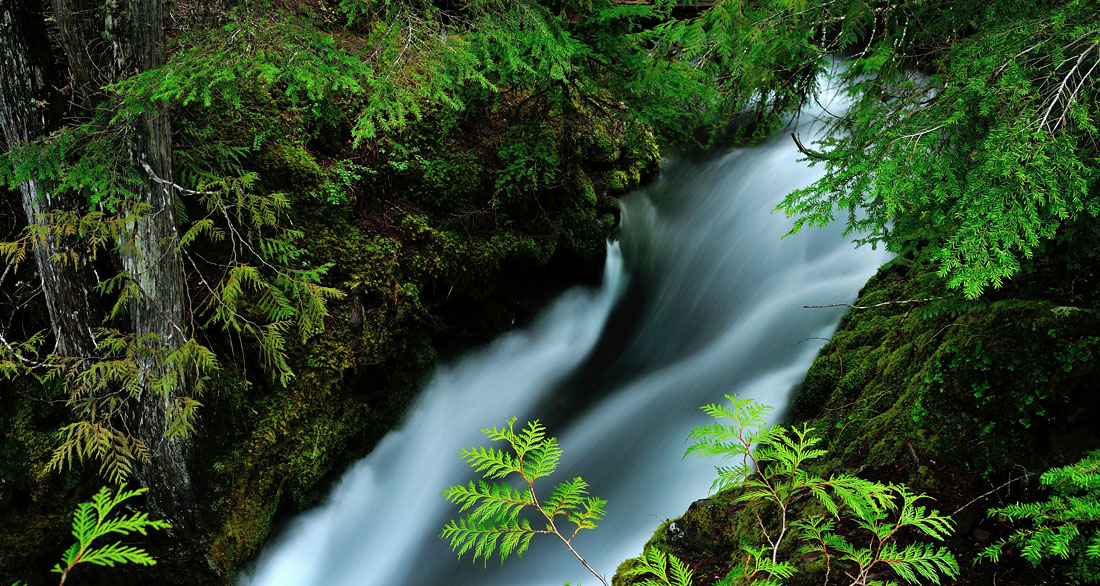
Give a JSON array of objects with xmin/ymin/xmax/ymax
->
[{"xmin": 688, "ymin": 395, "xmax": 959, "ymax": 585}]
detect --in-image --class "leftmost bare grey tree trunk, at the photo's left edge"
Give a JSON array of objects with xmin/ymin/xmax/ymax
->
[{"xmin": 0, "ymin": 0, "xmax": 96, "ymax": 356}]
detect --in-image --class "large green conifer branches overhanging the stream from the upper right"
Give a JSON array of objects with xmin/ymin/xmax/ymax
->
[{"xmin": 780, "ymin": 0, "xmax": 1100, "ymax": 298}]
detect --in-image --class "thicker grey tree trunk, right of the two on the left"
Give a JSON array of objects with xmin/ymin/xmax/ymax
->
[{"xmin": 52, "ymin": 0, "xmax": 195, "ymax": 529}]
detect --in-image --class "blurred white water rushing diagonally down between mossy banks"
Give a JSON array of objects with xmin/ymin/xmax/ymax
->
[{"xmin": 241, "ymin": 97, "xmax": 887, "ymax": 586}]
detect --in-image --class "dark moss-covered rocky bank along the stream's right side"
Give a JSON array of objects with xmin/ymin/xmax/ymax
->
[{"xmin": 615, "ymin": 257, "xmax": 1100, "ymax": 586}]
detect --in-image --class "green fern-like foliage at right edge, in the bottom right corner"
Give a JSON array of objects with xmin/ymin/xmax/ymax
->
[{"xmin": 979, "ymin": 451, "xmax": 1100, "ymax": 584}]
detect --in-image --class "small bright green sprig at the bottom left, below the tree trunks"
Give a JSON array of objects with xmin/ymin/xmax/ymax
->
[{"xmin": 53, "ymin": 486, "xmax": 172, "ymax": 584}]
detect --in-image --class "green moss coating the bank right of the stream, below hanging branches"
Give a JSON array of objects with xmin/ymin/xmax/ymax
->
[{"xmin": 791, "ymin": 261, "xmax": 1100, "ymax": 479}]
